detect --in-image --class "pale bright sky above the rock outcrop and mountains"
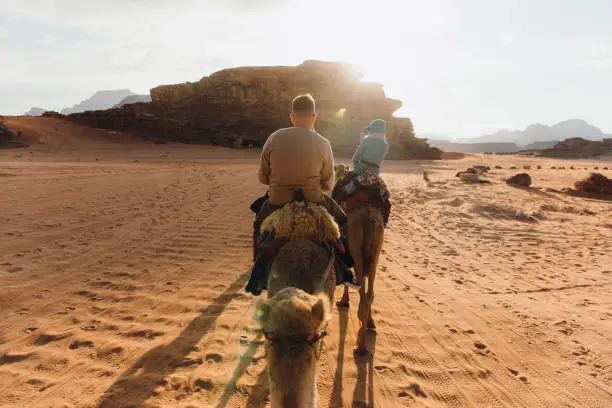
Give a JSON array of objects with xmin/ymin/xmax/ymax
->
[{"xmin": 0, "ymin": 0, "xmax": 612, "ymax": 138}]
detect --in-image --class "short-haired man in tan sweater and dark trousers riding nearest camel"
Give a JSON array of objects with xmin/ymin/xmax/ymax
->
[{"xmin": 247, "ymin": 94, "xmax": 359, "ymax": 294}]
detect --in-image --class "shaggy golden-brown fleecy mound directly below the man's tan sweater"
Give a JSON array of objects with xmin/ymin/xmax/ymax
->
[{"xmin": 261, "ymin": 202, "xmax": 340, "ymax": 244}]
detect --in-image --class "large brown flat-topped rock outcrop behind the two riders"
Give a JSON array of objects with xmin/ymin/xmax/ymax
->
[{"xmin": 70, "ymin": 61, "xmax": 442, "ymax": 159}]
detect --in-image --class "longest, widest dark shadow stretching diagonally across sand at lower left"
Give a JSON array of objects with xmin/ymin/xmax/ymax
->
[{"xmin": 97, "ymin": 272, "xmax": 249, "ymax": 408}]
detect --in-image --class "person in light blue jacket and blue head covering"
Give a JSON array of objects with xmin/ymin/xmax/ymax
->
[{"xmin": 353, "ymin": 119, "xmax": 389, "ymax": 175}]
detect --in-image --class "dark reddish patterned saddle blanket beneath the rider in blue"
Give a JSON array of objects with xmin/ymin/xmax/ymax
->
[{"xmin": 332, "ymin": 170, "xmax": 391, "ymax": 226}]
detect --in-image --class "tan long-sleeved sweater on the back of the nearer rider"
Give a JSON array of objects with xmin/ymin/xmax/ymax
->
[{"xmin": 259, "ymin": 127, "xmax": 334, "ymax": 204}]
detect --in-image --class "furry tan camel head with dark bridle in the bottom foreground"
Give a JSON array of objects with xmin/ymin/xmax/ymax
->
[{"xmin": 257, "ymin": 287, "xmax": 331, "ymax": 408}]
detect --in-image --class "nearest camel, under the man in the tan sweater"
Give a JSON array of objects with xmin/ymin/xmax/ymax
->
[{"xmin": 257, "ymin": 202, "xmax": 340, "ymax": 408}]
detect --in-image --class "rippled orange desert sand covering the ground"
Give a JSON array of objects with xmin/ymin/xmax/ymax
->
[{"xmin": 0, "ymin": 118, "xmax": 612, "ymax": 408}]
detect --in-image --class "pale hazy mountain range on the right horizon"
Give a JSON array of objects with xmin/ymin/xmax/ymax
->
[{"xmin": 462, "ymin": 119, "xmax": 612, "ymax": 146}]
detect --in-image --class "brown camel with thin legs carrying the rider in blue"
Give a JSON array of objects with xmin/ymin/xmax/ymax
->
[{"xmin": 335, "ymin": 164, "xmax": 385, "ymax": 354}]
